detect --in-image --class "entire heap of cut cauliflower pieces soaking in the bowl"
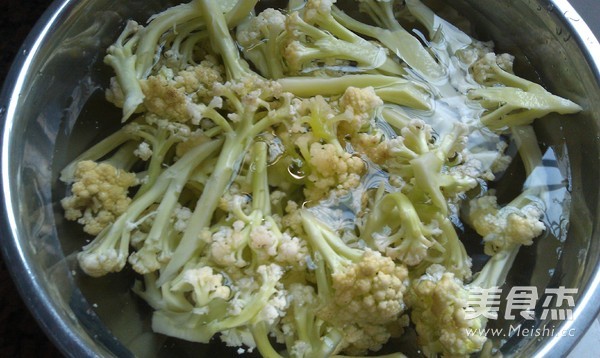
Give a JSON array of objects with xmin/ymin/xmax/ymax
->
[{"xmin": 60, "ymin": 0, "xmax": 581, "ymax": 358}]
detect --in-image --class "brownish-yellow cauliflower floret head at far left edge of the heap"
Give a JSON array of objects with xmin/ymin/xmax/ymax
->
[{"xmin": 61, "ymin": 160, "xmax": 137, "ymax": 236}]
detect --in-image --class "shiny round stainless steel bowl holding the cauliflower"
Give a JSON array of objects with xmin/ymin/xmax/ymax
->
[{"xmin": 0, "ymin": 0, "xmax": 600, "ymax": 357}]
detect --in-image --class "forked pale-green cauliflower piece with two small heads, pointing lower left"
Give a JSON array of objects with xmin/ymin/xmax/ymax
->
[{"xmin": 77, "ymin": 137, "xmax": 220, "ymax": 277}]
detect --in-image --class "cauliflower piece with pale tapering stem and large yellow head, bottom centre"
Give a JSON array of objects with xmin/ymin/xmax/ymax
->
[{"xmin": 302, "ymin": 213, "xmax": 408, "ymax": 330}]
